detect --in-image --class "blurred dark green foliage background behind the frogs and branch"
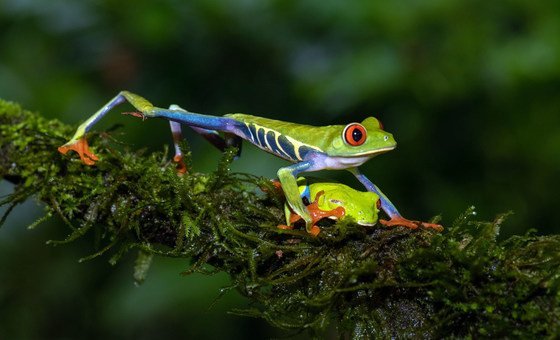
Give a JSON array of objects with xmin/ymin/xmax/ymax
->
[{"xmin": 0, "ymin": 0, "xmax": 560, "ymax": 339}]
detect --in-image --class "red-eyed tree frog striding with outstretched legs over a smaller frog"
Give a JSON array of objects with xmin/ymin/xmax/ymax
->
[{"xmin": 58, "ymin": 91, "xmax": 440, "ymax": 232}]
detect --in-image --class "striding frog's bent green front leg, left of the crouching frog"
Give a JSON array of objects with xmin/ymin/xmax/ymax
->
[{"xmin": 278, "ymin": 161, "xmax": 313, "ymax": 233}]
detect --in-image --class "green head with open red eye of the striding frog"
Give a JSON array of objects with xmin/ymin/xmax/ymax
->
[{"xmin": 327, "ymin": 117, "xmax": 397, "ymax": 158}]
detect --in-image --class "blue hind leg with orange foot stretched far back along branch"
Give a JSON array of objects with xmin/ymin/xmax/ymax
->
[{"xmin": 58, "ymin": 91, "xmax": 244, "ymax": 165}]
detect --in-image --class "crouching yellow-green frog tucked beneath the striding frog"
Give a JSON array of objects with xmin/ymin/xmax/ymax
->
[{"xmin": 280, "ymin": 177, "xmax": 381, "ymax": 235}]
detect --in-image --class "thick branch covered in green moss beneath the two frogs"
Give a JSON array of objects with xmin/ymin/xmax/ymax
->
[{"xmin": 0, "ymin": 101, "xmax": 560, "ymax": 338}]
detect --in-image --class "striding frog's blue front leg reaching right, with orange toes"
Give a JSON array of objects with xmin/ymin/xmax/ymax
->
[{"xmin": 348, "ymin": 168, "xmax": 443, "ymax": 231}]
